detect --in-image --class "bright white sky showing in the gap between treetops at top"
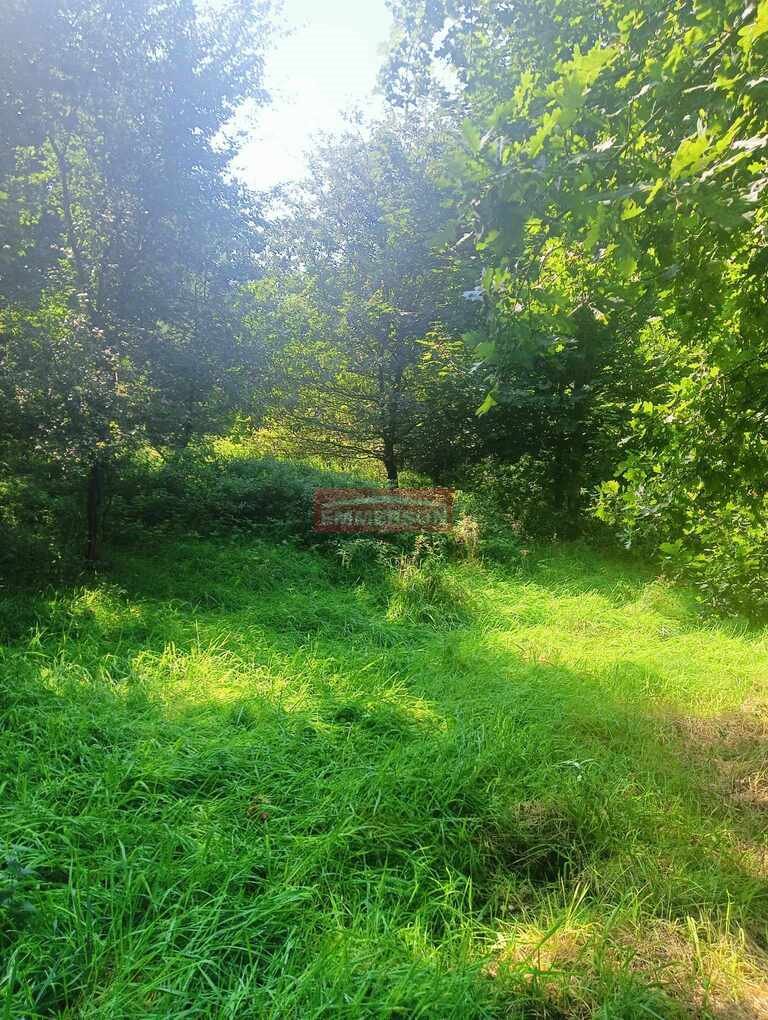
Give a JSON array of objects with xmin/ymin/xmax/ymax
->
[{"xmin": 233, "ymin": 0, "xmax": 392, "ymax": 190}]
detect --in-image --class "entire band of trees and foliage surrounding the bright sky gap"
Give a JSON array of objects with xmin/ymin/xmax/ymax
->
[{"xmin": 0, "ymin": 0, "xmax": 768, "ymax": 614}]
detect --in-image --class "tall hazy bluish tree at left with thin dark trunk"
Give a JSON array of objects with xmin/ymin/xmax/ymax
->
[{"xmin": 0, "ymin": 0, "xmax": 267, "ymax": 559}]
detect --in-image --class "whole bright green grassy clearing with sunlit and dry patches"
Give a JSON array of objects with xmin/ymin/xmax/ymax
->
[{"xmin": 0, "ymin": 540, "xmax": 768, "ymax": 1020}]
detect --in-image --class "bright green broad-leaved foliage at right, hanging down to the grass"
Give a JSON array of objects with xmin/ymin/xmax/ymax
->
[{"xmin": 382, "ymin": 0, "xmax": 768, "ymax": 616}]
